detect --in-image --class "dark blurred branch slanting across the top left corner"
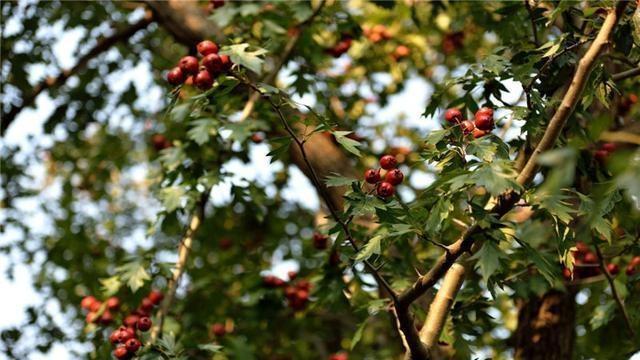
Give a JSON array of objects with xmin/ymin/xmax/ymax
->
[{"xmin": 0, "ymin": 12, "xmax": 153, "ymax": 136}]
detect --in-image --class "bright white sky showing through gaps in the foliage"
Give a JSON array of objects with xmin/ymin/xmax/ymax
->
[{"xmin": 0, "ymin": 4, "xmax": 640, "ymax": 360}]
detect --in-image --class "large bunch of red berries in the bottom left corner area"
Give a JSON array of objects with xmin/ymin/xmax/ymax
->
[{"xmin": 80, "ymin": 290, "xmax": 163, "ymax": 359}]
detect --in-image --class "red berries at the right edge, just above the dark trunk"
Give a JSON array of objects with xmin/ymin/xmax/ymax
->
[{"xmin": 562, "ymin": 241, "xmax": 640, "ymax": 280}]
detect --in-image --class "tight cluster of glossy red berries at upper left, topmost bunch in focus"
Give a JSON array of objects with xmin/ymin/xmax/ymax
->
[{"xmin": 167, "ymin": 40, "xmax": 232, "ymax": 90}]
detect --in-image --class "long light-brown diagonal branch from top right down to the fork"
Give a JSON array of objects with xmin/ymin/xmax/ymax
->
[{"xmin": 398, "ymin": 2, "xmax": 626, "ymax": 338}]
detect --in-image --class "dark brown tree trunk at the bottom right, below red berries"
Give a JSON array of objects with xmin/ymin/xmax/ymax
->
[{"xmin": 515, "ymin": 290, "xmax": 576, "ymax": 360}]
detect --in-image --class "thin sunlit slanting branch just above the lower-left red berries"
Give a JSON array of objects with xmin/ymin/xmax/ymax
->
[{"xmin": 149, "ymin": 190, "xmax": 210, "ymax": 344}]
